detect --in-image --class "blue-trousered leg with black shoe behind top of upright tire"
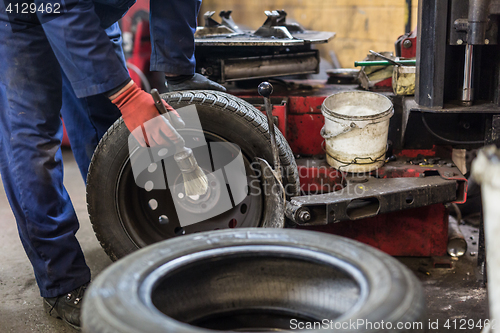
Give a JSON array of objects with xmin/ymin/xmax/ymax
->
[{"xmin": 149, "ymin": 0, "xmax": 226, "ymax": 91}]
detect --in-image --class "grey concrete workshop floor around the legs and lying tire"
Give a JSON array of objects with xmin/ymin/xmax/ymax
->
[{"xmin": 0, "ymin": 151, "xmax": 487, "ymax": 333}]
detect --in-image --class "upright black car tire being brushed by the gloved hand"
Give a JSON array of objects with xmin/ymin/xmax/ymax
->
[{"xmin": 87, "ymin": 91, "xmax": 300, "ymax": 260}]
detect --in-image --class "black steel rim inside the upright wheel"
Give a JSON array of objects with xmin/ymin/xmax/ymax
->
[{"xmin": 115, "ymin": 130, "xmax": 263, "ymax": 248}]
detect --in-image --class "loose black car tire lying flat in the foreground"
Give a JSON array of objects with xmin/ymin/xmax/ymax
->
[{"xmin": 82, "ymin": 228, "xmax": 427, "ymax": 333}]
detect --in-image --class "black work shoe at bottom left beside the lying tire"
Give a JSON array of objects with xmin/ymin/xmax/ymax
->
[{"xmin": 43, "ymin": 283, "xmax": 88, "ymax": 331}]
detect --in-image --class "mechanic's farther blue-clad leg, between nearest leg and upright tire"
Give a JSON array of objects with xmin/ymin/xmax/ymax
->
[{"xmin": 61, "ymin": 23, "xmax": 126, "ymax": 180}]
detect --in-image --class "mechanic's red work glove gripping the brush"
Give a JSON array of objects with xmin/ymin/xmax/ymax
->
[{"xmin": 111, "ymin": 81, "xmax": 184, "ymax": 147}]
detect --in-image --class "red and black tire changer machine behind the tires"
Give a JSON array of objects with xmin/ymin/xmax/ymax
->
[{"xmin": 123, "ymin": 0, "xmax": 500, "ymax": 260}]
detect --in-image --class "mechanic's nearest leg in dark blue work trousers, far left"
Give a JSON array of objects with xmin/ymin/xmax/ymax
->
[{"xmin": 0, "ymin": 8, "xmax": 90, "ymax": 297}]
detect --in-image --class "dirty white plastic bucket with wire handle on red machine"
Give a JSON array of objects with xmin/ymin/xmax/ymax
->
[{"xmin": 321, "ymin": 91, "xmax": 394, "ymax": 172}]
